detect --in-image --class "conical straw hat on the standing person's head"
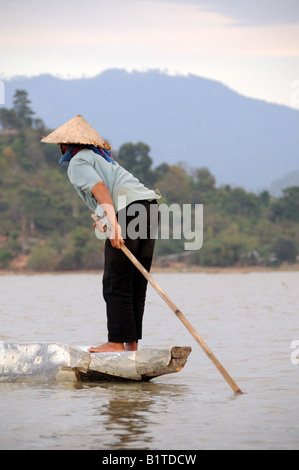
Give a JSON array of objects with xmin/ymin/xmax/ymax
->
[{"xmin": 41, "ymin": 114, "xmax": 110, "ymax": 149}]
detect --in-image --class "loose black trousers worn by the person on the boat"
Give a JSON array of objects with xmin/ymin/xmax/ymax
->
[{"xmin": 103, "ymin": 201, "xmax": 159, "ymax": 343}]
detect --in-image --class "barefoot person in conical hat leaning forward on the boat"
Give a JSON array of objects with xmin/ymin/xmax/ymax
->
[{"xmin": 42, "ymin": 115, "xmax": 161, "ymax": 353}]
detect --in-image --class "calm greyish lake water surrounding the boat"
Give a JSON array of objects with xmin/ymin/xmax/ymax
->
[{"xmin": 0, "ymin": 271, "xmax": 299, "ymax": 450}]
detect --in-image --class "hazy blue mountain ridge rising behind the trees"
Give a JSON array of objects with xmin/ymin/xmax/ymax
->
[{"xmin": 4, "ymin": 69, "xmax": 299, "ymax": 191}]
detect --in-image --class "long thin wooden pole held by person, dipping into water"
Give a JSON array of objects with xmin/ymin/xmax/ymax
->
[{"xmin": 92, "ymin": 214, "xmax": 243, "ymax": 394}]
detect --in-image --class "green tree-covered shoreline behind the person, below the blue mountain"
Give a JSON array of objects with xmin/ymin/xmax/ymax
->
[{"xmin": 0, "ymin": 90, "xmax": 299, "ymax": 271}]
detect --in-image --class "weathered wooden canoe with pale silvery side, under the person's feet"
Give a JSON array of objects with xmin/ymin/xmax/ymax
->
[{"xmin": 0, "ymin": 341, "xmax": 191, "ymax": 383}]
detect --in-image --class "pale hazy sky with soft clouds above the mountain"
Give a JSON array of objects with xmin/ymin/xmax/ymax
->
[{"xmin": 0, "ymin": 0, "xmax": 299, "ymax": 109}]
